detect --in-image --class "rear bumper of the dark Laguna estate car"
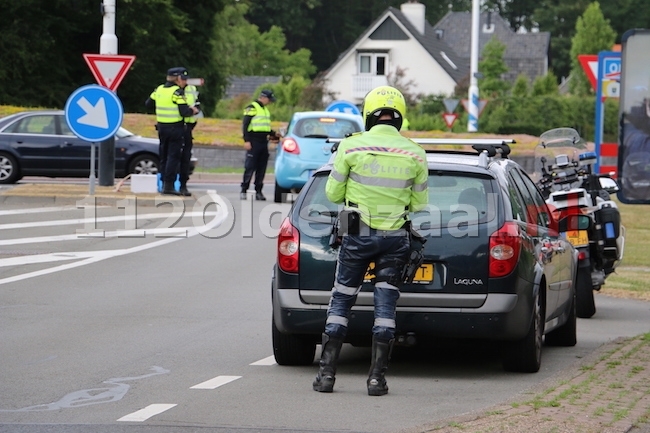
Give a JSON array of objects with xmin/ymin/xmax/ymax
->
[{"xmin": 273, "ymin": 289, "xmax": 532, "ymax": 340}]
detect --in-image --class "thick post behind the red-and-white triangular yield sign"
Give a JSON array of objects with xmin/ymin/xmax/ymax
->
[{"xmin": 98, "ymin": 0, "xmax": 117, "ymax": 186}]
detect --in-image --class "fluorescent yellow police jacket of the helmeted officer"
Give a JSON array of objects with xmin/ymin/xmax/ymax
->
[{"xmin": 325, "ymin": 124, "xmax": 429, "ymax": 230}]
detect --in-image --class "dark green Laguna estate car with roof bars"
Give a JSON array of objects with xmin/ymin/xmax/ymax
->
[{"xmin": 272, "ymin": 139, "xmax": 577, "ymax": 372}]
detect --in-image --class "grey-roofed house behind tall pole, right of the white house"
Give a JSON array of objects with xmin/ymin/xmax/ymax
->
[{"xmin": 433, "ymin": 12, "xmax": 551, "ymax": 82}]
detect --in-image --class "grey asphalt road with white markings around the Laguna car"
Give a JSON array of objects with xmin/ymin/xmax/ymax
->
[{"xmin": 0, "ymin": 182, "xmax": 650, "ymax": 433}]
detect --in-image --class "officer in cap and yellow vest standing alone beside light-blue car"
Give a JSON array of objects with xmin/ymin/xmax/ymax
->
[{"xmin": 239, "ymin": 90, "xmax": 279, "ymax": 200}]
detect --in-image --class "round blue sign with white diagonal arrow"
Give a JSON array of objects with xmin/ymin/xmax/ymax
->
[{"xmin": 64, "ymin": 84, "xmax": 124, "ymax": 142}]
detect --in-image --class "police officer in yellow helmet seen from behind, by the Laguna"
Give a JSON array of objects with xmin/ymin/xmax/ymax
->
[{"xmin": 313, "ymin": 86, "xmax": 428, "ymax": 395}]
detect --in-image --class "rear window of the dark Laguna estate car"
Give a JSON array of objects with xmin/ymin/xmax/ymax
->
[{"xmin": 300, "ymin": 172, "xmax": 497, "ymax": 229}]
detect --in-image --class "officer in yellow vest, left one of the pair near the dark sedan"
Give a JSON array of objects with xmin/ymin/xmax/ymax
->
[{"xmin": 145, "ymin": 67, "xmax": 199, "ymax": 195}]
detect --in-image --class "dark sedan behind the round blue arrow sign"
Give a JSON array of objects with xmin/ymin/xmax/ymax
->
[{"xmin": 0, "ymin": 111, "xmax": 196, "ymax": 184}]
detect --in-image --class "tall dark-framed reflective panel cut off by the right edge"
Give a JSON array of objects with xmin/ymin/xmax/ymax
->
[{"xmin": 617, "ymin": 29, "xmax": 650, "ymax": 204}]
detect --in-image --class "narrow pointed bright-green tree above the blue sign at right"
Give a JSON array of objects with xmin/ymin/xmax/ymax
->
[{"xmin": 569, "ymin": 2, "xmax": 616, "ymax": 95}]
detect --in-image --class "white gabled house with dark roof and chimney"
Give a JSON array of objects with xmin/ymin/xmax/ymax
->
[{"xmin": 324, "ymin": 2, "xmax": 469, "ymax": 104}]
